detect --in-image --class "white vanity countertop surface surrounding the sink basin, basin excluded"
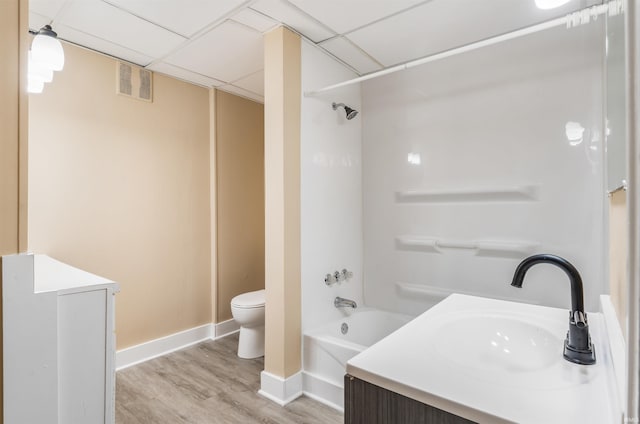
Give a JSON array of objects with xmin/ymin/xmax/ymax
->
[{"xmin": 347, "ymin": 294, "xmax": 621, "ymax": 424}]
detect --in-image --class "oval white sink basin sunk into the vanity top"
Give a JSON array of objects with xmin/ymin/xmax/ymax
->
[{"xmin": 435, "ymin": 313, "xmax": 562, "ymax": 375}]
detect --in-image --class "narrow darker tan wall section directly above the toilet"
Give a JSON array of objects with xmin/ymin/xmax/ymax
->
[{"xmin": 215, "ymin": 90, "xmax": 264, "ymax": 322}]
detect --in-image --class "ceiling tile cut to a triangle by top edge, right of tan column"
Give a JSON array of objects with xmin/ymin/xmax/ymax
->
[{"xmin": 289, "ymin": 0, "xmax": 428, "ymax": 34}]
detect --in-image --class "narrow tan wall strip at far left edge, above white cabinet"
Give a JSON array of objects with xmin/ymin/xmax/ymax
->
[{"xmin": 0, "ymin": 0, "xmax": 28, "ymax": 423}]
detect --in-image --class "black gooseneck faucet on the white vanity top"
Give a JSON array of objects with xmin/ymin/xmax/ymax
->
[{"xmin": 511, "ymin": 254, "xmax": 596, "ymax": 365}]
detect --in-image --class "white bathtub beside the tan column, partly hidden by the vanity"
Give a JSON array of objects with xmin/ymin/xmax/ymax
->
[{"xmin": 303, "ymin": 308, "xmax": 413, "ymax": 409}]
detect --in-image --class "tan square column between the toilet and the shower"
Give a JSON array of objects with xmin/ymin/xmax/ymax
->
[{"xmin": 264, "ymin": 27, "xmax": 302, "ymax": 378}]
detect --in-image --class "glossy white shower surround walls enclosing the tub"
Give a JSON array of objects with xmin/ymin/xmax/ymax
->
[{"xmin": 301, "ymin": 17, "xmax": 605, "ymax": 406}]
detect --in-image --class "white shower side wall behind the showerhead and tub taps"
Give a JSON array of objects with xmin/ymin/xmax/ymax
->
[{"xmin": 300, "ymin": 42, "xmax": 362, "ymax": 331}]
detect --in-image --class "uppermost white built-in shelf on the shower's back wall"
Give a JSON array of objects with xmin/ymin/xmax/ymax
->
[{"xmin": 395, "ymin": 185, "xmax": 539, "ymax": 203}]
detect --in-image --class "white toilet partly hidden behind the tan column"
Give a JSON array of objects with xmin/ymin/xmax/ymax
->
[{"xmin": 231, "ymin": 289, "xmax": 265, "ymax": 359}]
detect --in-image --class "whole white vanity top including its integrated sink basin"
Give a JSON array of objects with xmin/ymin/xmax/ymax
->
[{"xmin": 347, "ymin": 295, "xmax": 619, "ymax": 424}]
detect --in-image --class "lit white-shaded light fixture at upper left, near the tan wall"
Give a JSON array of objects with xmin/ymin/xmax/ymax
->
[{"xmin": 27, "ymin": 25, "xmax": 64, "ymax": 93}]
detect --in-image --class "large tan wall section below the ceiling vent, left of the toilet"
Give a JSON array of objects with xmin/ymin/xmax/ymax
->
[{"xmin": 29, "ymin": 44, "xmax": 211, "ymax": 349}]
